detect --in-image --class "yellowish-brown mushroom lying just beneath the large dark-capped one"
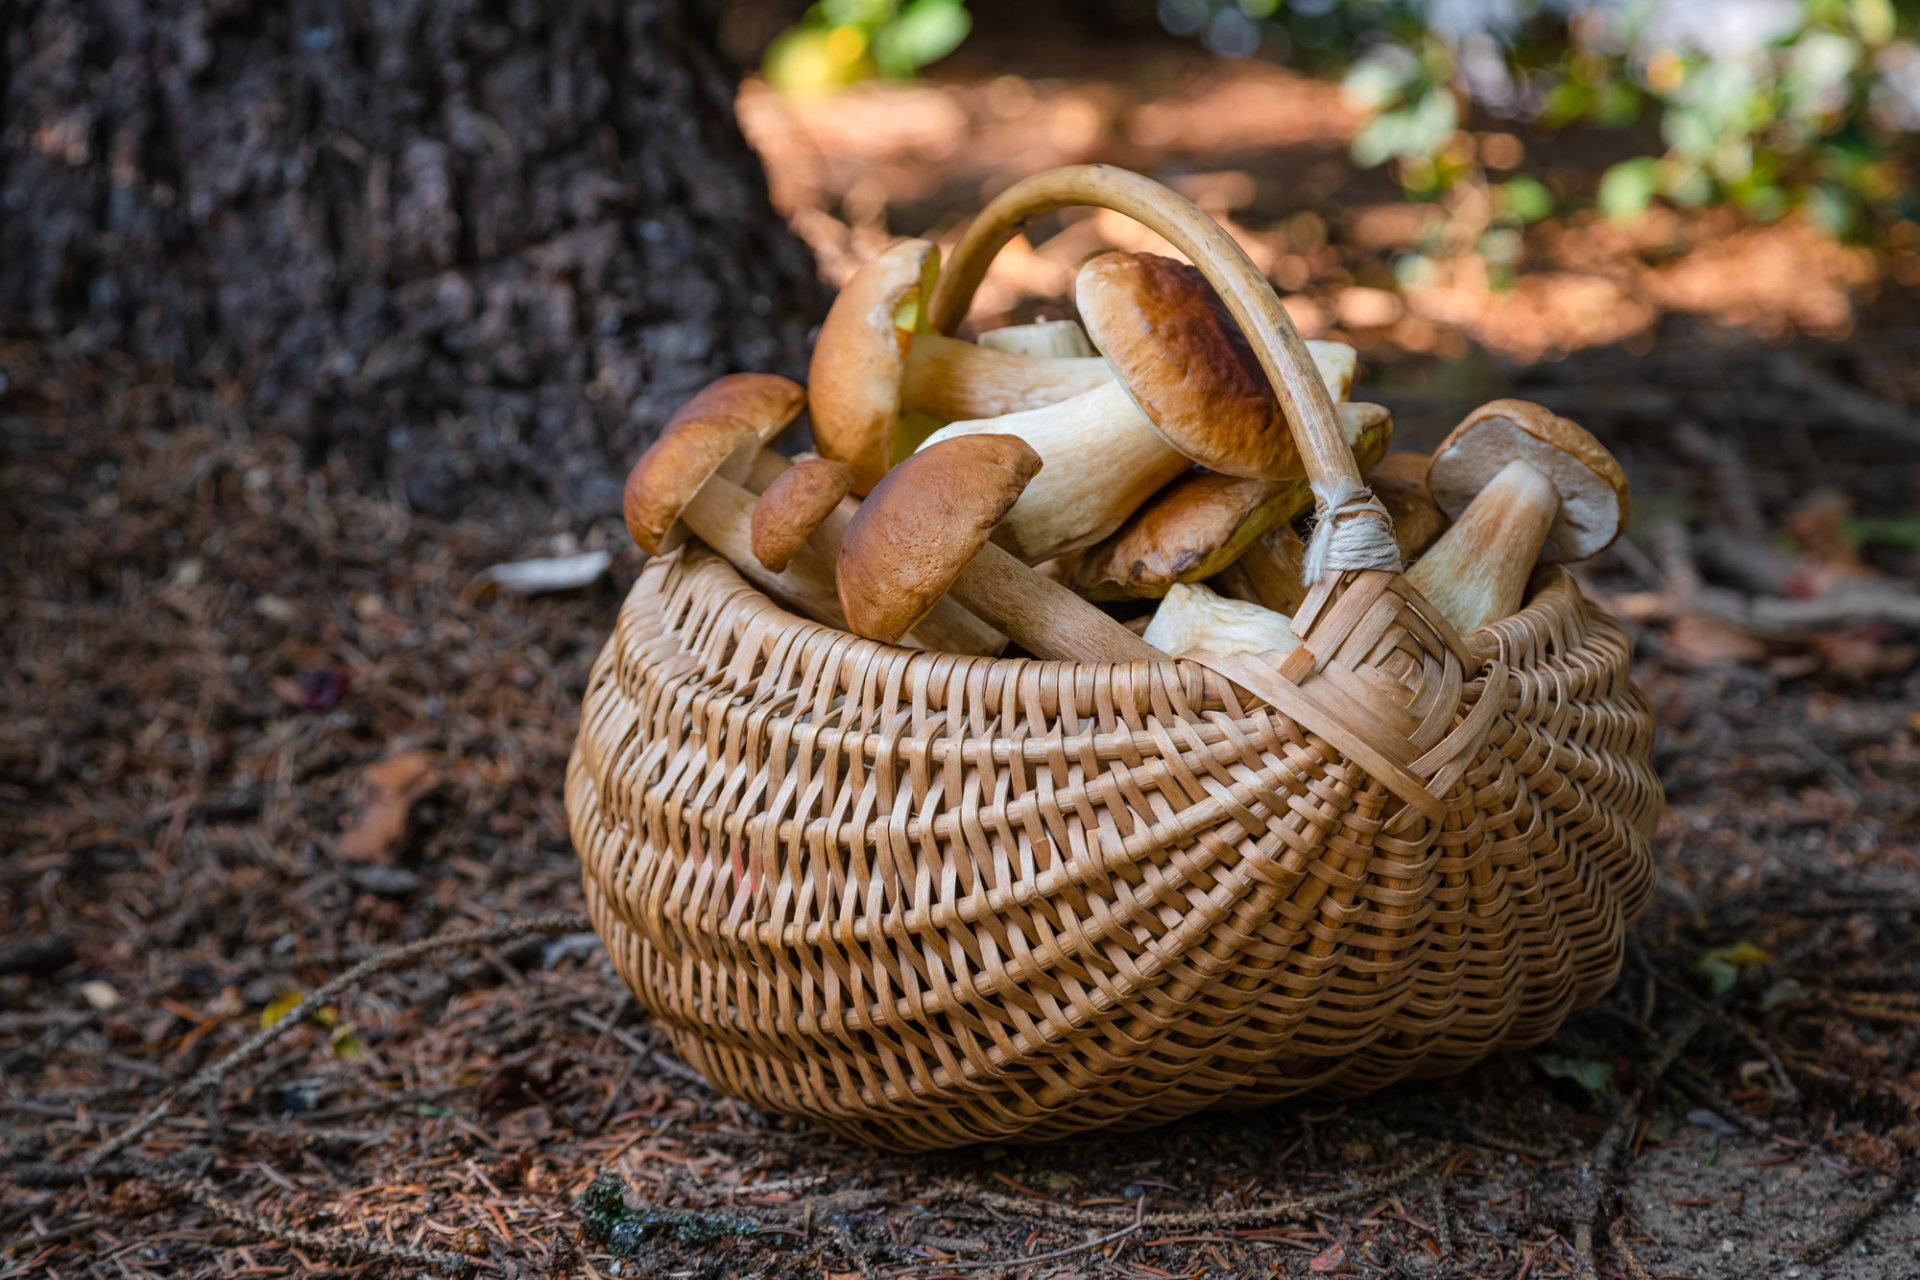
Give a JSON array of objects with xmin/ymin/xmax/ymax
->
[{"xmin": 1073, "ymin": 403, "xmax": 1394, "ymax": 603}]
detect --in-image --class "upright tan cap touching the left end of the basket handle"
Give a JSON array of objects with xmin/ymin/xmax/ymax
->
[{"xmin": 806, "ymin": 240, "xmax": 941, "ymax": 493}]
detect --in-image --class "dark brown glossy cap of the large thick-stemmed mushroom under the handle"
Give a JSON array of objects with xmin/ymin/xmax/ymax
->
[{"xmin": 1073, "ymin": 253, "xmax": 1302, "ymax": 480}]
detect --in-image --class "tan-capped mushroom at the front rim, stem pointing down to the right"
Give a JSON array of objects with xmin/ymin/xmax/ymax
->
[{"xmin": 839, "ymin": 436, "xmax": 1165, "ymax": 662}]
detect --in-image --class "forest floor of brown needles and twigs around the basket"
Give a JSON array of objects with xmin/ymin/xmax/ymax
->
[{"xmin": 0, "ymin": 37, "xmax": 1920, "ymax": 1280}]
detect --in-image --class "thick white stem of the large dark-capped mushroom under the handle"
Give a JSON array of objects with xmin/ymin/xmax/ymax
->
[{"xmin": 922, "ymin": 380, "xmax": 1192, "ymax": 564}]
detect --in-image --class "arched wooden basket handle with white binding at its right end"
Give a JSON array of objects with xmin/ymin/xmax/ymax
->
[{"xmin": 927, "ymin": 165, "xmax": 1400, "ymax": 583}]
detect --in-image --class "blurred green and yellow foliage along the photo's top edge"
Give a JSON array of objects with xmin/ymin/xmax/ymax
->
[{"xmin": 764, "ymin": 0, "xmax": 1920, "ymax": 239}]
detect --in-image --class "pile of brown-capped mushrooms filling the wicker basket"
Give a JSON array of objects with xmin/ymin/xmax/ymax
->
[{"xmin": 626, "ymin": 240, "xmax": 1628, "ymax": 662}]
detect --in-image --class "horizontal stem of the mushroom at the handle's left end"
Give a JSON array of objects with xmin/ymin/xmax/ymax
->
[{"xmin": 900, "ymin": 334, "xmax": 1114, "ymax": 422}]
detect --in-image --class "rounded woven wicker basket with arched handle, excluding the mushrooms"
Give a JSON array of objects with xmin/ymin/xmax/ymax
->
[{"xmin": 566, "ymin": 171, "xmax": 1663, "ymax": 1150}]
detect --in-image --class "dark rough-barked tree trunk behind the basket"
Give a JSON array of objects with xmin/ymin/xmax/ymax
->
[{"xmin": 0, "ymin": 0, "xmax": 826, "ymax": 516}]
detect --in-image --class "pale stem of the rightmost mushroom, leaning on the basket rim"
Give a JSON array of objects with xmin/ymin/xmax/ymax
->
[{"xmin": 1407, "ymin": 459, "xmax": 1561, "ymax": 635}]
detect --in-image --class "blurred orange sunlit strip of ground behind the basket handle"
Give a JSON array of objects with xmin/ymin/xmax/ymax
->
[{"xmin": 739, "ymin": 59, "xmax": 1889, "ymax": 361}]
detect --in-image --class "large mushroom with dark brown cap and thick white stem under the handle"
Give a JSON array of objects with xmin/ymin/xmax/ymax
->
[{"xmin": 927, "ymin": 253, "xmax": 1352, "ymax": 564}]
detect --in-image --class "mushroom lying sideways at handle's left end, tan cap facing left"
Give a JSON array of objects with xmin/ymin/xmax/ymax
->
[{"xmin": 808, "ymin": 240, "xmax": 1114, "ymax": 493}]
